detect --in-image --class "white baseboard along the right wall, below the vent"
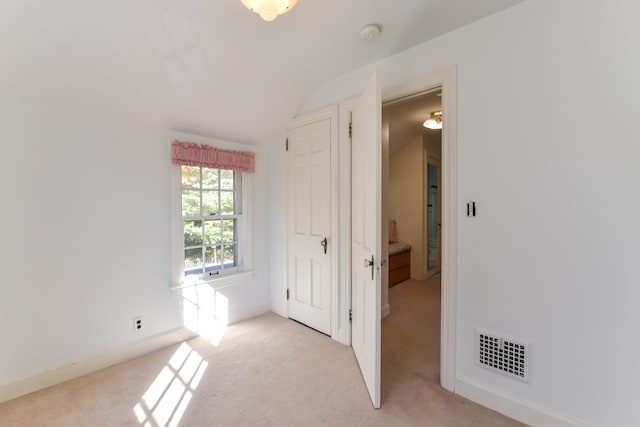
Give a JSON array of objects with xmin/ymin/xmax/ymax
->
[{"xmin": 455, "ymin": 377, "xmax": 588, "ymax": 427}]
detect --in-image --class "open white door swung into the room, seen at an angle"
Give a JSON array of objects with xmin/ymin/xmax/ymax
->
[{"xmin": 351, "ymin": 74, "xmax": 382, "ymax": 408}]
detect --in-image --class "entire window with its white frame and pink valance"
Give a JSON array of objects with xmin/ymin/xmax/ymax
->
[{"xmin": 171, "ymin": 141, "xmax": 255, "ymax": 290}]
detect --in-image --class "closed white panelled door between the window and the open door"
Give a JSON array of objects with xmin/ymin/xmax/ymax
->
[{"xmin": 287, "ymin": 119, "xmax": 332, "ymax": 335}]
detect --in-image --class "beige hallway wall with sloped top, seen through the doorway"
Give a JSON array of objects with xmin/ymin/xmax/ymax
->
[{"xmin": 386, "ymin": 135, "xmax": 425, "ymax": 280}]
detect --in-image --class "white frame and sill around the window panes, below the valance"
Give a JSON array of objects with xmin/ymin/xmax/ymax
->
[{"xmin": 170, "ymin": 164, "xmax": 253, "ymax": 291}]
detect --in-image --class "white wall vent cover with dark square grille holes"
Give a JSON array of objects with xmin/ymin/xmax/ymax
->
[{"xmin": 476, "ymin": 329, "xmax": 531, "ymax": 382}]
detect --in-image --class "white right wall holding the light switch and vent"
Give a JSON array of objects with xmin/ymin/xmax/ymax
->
[{"xmin": 301, "ymin": 0, "xmax": 640, "ymax": 426}]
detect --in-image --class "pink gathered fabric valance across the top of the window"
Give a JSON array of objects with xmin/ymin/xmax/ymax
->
[{"xmin": 171, "ymin": 141, "xmax": 256, "ymax": 172}]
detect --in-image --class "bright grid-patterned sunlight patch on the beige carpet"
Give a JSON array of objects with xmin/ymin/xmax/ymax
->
[{"xmin": 133, "ymin": 343, "xmax": 208, "ymax": 427}]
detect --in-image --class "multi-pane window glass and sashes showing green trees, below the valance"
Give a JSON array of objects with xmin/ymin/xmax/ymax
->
[{"xmin": 181, "ymin": 166, "xmax": 242, "ymax": 278}]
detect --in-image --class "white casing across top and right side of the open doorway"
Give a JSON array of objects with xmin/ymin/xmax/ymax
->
[{"xmin": 382, "ymin": 66, "xmax": 458, "ymax": 391}]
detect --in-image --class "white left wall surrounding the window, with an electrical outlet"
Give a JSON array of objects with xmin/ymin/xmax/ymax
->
[{"xmin": 0, "ymin": 100, "xmax": 270, "ymax": 383}]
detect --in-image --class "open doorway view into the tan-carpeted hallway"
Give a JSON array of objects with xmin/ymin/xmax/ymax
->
[{"xmin": 382, "ymin": 87, "xmax": 442, "ymax": 399}]
